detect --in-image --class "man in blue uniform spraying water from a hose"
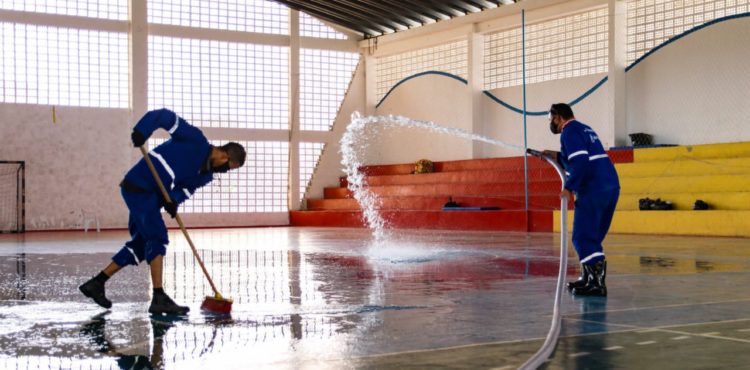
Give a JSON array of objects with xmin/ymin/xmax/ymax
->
[{"xmin": 549, "ymin": 103, "xmax": 620, "ymax": 296}]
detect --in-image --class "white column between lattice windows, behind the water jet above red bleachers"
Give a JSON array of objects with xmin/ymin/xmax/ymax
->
[{"xmin": 468, "ymin": 24, "xmax": 486, "ymax": 159}]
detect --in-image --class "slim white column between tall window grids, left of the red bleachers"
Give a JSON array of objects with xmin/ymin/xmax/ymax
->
[{"xmin": 288, "ymin": 9, "xmax": 301, "ymax": 211}]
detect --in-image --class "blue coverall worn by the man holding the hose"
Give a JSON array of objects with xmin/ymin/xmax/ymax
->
[{"xmin": 560, "ymin": 120, "xmax": 620, "ymax": 265}]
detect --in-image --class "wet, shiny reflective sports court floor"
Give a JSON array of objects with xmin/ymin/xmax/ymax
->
[{"xmin": 0, "ymin": 228, "xmax": 750, "ymax": 369}]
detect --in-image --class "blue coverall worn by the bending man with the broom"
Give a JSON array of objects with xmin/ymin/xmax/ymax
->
[{"xmin": 112, "ymin": 109, "xmax": 213, "ymax": 266}]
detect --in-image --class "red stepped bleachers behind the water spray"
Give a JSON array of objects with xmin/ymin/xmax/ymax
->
[{"xmin": 290, "ymin": 150, "xmax": 632, "ymax": 231}]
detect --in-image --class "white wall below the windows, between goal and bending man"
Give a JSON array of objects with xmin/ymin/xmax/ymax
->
[{"xmin": 0, "ymin": 104, "xmax": 134, "ymax": 230}]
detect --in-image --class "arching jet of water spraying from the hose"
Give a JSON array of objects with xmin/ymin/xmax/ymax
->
[{"xmin": 340, "ymin": 112, "xmax": 523, "ymax": 240}]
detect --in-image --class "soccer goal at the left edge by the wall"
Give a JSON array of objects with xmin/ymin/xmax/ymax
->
[{"xmin": 0, "ymin": 161, "xmax": 26, "ymax": 233}]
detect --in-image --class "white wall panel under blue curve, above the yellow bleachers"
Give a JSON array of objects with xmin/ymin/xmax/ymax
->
[{"xmin": 626, "ymin": 17, "xmax": 750, "ymax": 144}]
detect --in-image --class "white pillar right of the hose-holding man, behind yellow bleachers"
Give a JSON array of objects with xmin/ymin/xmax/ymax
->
[{"xmin": 605, "ymin": 0, "xmax": 630, "ymax": 146}]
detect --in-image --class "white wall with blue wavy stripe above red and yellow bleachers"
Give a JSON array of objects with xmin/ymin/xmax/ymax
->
[{"xmin": 352, "ymin": 11, "xmax": 750, "ymax": 164}]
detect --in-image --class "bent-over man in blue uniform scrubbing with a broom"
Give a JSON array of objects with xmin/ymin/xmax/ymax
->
[{"xmin": 79, "ymin": 109, "xmax": 246, "ymax": 314}]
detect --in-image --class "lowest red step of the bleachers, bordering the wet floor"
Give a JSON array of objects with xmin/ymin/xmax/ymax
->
[{"xmin": 290, "ymin": 210, "xmax": 552, "ymax": 232}]
